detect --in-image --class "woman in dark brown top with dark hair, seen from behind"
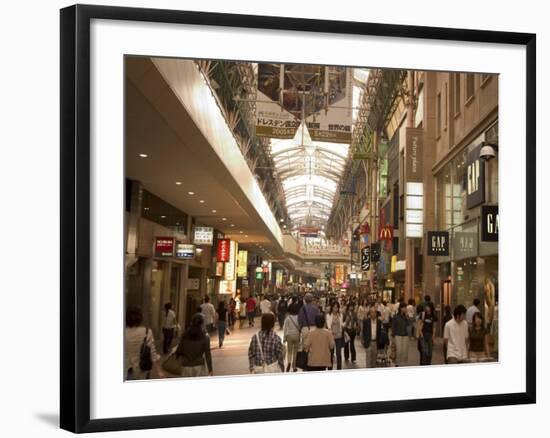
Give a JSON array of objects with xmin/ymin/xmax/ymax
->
[{"xmin": 176, "ymin": 313, "xmax": 213, "ymax": 377}]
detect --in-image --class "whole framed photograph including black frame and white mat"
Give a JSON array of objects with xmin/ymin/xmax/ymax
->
[{"xmin": 60, "ymin": 5, "xmax": 536, "ymax": 433}]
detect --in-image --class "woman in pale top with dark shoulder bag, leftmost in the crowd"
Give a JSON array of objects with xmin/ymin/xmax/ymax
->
[{"xmin": 124, "ymin": 306, "xmax": 164, "ymax": 380}]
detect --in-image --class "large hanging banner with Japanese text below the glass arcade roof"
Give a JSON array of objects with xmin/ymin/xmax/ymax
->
[{"xmin": 256, "ymin": 64, "xmax": 353, "ymax": 143}]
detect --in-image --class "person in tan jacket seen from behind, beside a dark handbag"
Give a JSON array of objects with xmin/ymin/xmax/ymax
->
[{"xmin": 304, "ymin": 313, "xmax": 336, "ymax": 371}]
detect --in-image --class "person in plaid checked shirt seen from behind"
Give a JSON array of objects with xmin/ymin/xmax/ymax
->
[{"xmin": 248, "ymin": 313, "xmax": 285, "ymax": 372}]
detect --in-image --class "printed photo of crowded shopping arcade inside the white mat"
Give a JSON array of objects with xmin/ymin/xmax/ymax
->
[{"xmin": 123, "ymin": 56, "xmax": 500, "ymax": 380}]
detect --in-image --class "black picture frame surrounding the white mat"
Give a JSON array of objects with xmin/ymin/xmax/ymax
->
[{"xmin": 60, "ymin": 5, "xmax": 536, "ymax": 433}]
